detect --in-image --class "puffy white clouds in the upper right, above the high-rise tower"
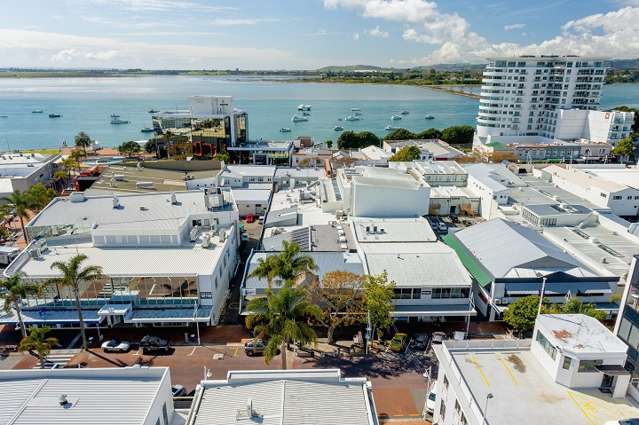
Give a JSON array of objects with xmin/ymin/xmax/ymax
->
[{"xmin": 324, "ymin": 0, "xmax": 639, "ymax": 65}]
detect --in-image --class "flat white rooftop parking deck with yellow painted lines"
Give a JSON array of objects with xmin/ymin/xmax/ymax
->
[{"xmin": 444, "ymin": 341, "xmax": 639, "ymax": 425}]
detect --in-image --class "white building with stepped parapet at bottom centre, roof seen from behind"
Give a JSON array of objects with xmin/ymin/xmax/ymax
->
[{"xmin": 186, "ymin": 369, "xmax": 379, "ymax": 425}]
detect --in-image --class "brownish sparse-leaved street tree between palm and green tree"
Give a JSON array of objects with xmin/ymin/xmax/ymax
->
[{"xmin": 308, "ymin": 271, "xmax": 366, "ymax": 343}]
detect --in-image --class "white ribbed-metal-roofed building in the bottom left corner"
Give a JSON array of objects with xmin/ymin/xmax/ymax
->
[{"xmin": 0, "ymin": 367, "xmax": 175, "ymax": 425}]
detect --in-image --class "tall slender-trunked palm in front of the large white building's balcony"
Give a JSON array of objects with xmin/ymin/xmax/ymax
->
[{"xmin": 50, "ymin": 254, "xmax": 103, "ymax": 350}]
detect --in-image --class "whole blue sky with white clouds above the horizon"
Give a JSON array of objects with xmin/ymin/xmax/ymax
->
[{"xmin": 0, "ymin": 0, "xmax": 639, "ymax": 69}]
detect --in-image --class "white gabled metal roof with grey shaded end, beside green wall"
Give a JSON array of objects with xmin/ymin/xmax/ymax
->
[{"xmin": 455, "ymin": 219, "xmax": 595, "ymax": 278}]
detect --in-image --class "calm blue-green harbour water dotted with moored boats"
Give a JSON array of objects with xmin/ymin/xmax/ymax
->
[{"xmin": 0, "ymin": 76, "xmax": 639, "ymax": 149}]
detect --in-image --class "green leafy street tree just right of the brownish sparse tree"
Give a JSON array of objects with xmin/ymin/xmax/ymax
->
[{"xmin": 364, "ymin": 273, "xmax": 395, "ymax": 338}]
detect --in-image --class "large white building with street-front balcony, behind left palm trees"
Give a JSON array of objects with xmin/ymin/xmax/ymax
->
[{"xmin": 0, "ymin": 190, "xmax": 239, "ymax": 327}]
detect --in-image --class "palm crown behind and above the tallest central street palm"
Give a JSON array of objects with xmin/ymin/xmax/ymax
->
[{"xmin": 249, "ymin": 241, "xmax": 317, "ymax": 288}]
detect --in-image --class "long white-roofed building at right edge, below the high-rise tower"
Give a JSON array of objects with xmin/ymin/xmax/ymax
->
[{"xmin": 542, "ymin": 165, "xmax": 639, "ymax": 217}]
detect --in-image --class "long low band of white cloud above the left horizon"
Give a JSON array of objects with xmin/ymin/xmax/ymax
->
[{"xmin": 0, "ymin": 29, "xmax": 292, "ymax": 69}]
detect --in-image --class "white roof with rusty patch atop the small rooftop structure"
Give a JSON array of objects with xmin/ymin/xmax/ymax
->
[{"xmin": 536, "ymin": 314, "xmax": 628, "ymax": 354}]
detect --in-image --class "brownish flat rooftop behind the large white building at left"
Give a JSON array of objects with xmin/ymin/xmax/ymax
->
[{"xmin": 86, "ymin": 165, "xmax": 220, "ymax": 195}]
